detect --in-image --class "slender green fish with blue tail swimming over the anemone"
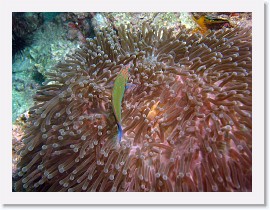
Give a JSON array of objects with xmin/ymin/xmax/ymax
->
[{"xmin": 112, "ymin": 65, "xmax": 130, "ymax": 142}]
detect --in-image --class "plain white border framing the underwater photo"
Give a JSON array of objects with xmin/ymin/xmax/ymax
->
[{"xmin": 0, "ymin": 0, "xmax": 265, "ymax": 205}]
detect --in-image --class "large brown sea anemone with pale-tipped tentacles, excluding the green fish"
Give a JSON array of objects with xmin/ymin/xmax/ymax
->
[{"xmin": 14, "ymin": 21, "xmax": 252, "ymax": 192}]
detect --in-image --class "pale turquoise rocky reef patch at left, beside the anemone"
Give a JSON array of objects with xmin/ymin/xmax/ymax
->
[{"xmin": 12, "ymin": 15, "xmax": 79, "ymax": 122}]
